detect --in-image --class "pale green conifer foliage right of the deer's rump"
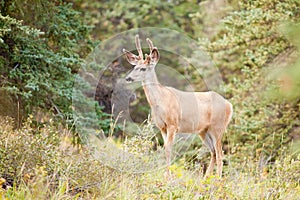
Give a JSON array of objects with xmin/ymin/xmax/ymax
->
[{"xmin": 195, "ymin": 0, "xmax": 299, "ymax": 161}]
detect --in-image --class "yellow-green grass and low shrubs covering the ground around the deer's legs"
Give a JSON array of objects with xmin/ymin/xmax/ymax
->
[{"xmin": 0, "ymin": 117, "xmax": 300, "ymax": 200}]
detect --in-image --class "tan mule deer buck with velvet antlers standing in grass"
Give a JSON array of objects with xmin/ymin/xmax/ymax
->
[{"xmin": 123, "ymin": 35, "xmax": 233, "ymax": 177}]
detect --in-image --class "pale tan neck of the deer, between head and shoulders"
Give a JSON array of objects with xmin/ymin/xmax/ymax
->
[{"xmin": 142, "ymin": 70, "xmax": 163, "ymax": 106}]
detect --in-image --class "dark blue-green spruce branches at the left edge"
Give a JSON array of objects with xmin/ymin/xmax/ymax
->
[{"xmin": 0, "ymin": 1, "xmax": 87, "ymax": 117}]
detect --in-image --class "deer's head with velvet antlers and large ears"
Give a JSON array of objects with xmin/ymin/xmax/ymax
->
[{"xmin": 123, "ymin": 35, "xmax": 159, "ymax": 82}]
